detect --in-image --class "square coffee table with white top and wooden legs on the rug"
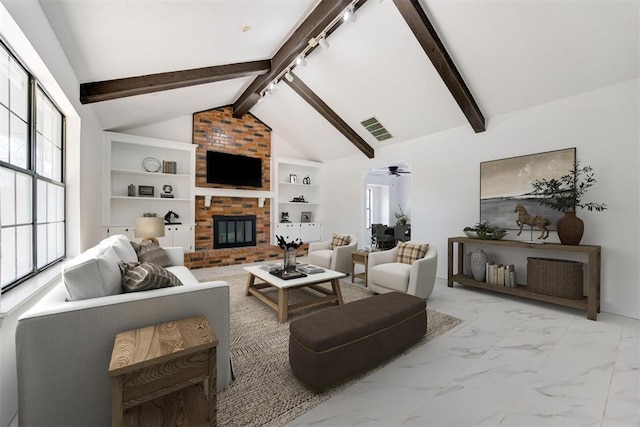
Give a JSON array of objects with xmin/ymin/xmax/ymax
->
[{"xmin": 244, "ymin": 266, "xmax": 346, "ymax": 323}]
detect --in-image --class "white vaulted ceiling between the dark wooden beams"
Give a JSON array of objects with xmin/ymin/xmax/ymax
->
[{"xmin": 39, "ymin": 0, "xmax": 640, "ymax": 161}]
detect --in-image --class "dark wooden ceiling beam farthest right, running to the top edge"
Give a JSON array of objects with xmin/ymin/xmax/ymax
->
[{"xmin": 393, "ymin": 0, "xmax": 486, "ymax": 133}]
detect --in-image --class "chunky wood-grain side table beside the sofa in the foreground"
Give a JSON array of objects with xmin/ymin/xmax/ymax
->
[{"xmin": 109, "ymin": 316, "xmax": 218, "ymax": 426}]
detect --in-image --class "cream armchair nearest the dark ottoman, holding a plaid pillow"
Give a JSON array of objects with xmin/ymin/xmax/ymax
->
[{"xmin": 368, "ymin": 242, "xmax": 438, "ymax": 298}]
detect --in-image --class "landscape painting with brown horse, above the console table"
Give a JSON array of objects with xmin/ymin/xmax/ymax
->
[{"xmin": 480, "ymin": 147, "xmax": 576, "ymax": 234}]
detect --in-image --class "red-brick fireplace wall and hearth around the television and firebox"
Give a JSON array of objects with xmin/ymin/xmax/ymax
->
[{"xmin": 185, "ymin": 106, "xmax": 292, "ymax": 268}]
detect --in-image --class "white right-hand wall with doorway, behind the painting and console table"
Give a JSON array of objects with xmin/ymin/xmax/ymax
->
[{"xmin": 323, "ymin": 79, "xmax": 640, "ymax": 318}]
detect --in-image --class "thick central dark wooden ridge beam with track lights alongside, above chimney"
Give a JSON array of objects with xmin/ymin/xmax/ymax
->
[{"xmin": 233, "ymin": 0, "xmax": 358, "ymax": 118}]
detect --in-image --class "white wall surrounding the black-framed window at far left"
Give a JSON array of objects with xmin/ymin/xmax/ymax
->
[{"xmin": 0, "ymin": 0, "xmax": 102, "ymax": 426}]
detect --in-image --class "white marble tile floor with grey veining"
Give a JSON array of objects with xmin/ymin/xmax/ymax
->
[{"xmin": 194, "ymin": 260, "xmax": 640, "ymax": 427}]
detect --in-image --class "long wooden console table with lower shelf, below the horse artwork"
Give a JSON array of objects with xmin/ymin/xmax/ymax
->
[{"xmin": 447, "ymin": 237, "xmax": 600, "ymax": 320}]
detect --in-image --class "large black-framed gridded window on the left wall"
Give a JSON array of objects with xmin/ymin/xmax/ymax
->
[{"xmin": 0, "ymin": 43, "xmax": 65, "ymax": 292}]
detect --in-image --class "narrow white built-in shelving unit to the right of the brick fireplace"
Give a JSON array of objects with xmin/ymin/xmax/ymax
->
[{"xmin": 271, "ymin": 157, "xmax": 322, "ymax": 244}]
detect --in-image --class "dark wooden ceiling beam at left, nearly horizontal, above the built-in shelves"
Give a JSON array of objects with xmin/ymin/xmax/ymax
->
[{"xmin": 80, "ymin": 60, "xmax": 271, "ymax": 104}]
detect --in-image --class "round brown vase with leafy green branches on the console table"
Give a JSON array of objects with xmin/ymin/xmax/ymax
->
[{"xmin": 531, "ymin": 160, "xmax": 607, "ymax": 245}]
